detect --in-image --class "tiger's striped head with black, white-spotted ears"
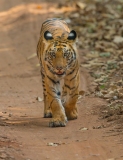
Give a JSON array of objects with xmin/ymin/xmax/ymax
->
[{"xmin": 44, "ymin": 30, "xmax": 77, "ymax": 77}]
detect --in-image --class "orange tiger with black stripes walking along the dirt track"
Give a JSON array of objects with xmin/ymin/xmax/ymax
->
[{"xmin": 37, "ymin": 18, "xmax": 79, "ymax": 127}]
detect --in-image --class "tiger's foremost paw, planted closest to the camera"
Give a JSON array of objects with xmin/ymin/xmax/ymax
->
[{"xmin": 49, "ymin": 117, "xmax": 67, "ymax": 127}]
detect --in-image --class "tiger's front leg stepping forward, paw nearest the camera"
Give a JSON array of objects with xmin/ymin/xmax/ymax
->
[{"xmin": 46, "ymin": 76, "xmax": 67, "ymax": 127}]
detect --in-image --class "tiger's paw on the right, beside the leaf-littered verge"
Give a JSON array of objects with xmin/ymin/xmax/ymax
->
[{"xmin": 65, "ymin": 108, "xmax": 78, "ymax": 120}]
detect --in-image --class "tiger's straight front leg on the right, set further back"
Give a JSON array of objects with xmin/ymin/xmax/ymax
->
[{"xmin": 64, "ymin": 71, "xmax": 79, "ymax": 120}]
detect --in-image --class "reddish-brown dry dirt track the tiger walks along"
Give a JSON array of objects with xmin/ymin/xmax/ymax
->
[{"xmin": 0, "ymin": 0, "xmax": 123, "ymax": 160}]
